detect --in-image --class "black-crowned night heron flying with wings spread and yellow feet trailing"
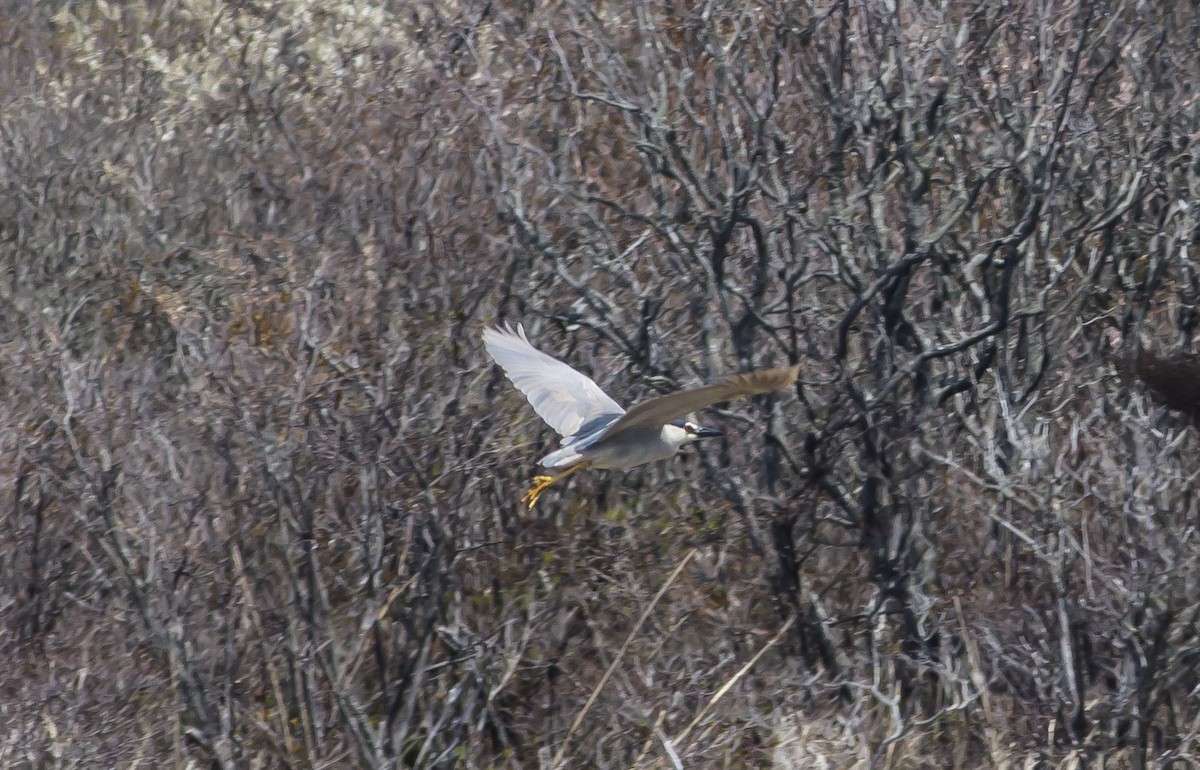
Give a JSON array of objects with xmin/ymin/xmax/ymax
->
[{"xmin": 484, "ymin": 325, "xmax": 800, "ymax": 509}]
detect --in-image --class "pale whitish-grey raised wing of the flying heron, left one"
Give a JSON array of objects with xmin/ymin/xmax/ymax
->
[{"xmin": 484, "ymin": 324, "xmax": 625, "ymax": 435}]
